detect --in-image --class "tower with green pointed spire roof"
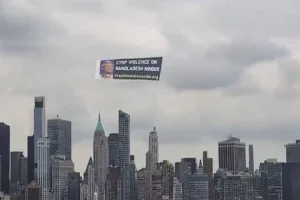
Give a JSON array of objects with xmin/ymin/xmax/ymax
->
[{"xmin": 94, "ymin": 113, "xmax": 108, "ymax": 200}]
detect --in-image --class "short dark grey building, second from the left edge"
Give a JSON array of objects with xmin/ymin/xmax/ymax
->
[{"xmin": 10, "ymin": 151, "xmax": 24, "ymax": 195}]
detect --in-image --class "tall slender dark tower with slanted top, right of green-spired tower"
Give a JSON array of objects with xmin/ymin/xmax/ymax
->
[{"xmin": 119, "ymin": 110, "xmax": 131, "ymax": 200}]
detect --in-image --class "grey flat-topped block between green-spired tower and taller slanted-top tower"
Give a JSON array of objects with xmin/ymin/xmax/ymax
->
[{"xmin": 107, "ymin": 133, "xmax": 120, "ymax": 166}]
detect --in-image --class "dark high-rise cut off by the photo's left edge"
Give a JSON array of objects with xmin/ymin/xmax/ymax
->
[{"xmin": 0, "ymin": 122, "xmax": 10, "ymax": 194}]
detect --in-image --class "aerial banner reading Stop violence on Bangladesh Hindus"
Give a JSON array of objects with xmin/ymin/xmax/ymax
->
[{"xmin": 96, "ymin": 57, "xmax": 162, "ymax": 81}]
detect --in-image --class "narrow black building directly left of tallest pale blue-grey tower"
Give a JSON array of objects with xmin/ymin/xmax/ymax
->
[{"xmin": 27, "ymin": 136, "xmax": 35, "ymax": 184}]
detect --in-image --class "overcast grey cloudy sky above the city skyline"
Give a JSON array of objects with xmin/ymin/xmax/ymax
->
[{"xmin": 0, "ymin": 0, "xmax": 300, "ymax": 172}]
